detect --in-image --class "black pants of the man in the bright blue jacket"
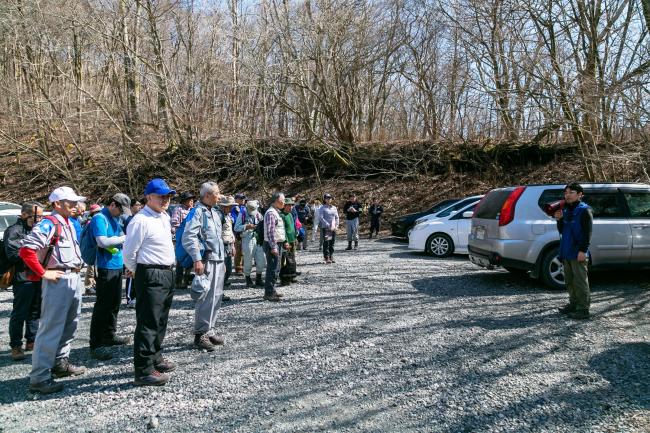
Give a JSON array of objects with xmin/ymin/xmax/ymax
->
[{"xmin": 90, "ymin": 268, "xmax": 124, "ymax": 349}]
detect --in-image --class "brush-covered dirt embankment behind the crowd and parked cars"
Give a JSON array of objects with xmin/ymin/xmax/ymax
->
[{"xmin": 0, "ymin": 134, "xmax": 650, "ymax": 223}]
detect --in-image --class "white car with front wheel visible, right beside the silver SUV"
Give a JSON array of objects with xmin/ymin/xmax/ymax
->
[{"xmin": 409, "ymin": 200, "xmax": 479, "ymax": 257}]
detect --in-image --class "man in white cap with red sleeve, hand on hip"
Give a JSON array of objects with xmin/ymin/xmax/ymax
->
[{"xmin": 19, "ymin": 186, "xmax": 86, "ymax": 394}]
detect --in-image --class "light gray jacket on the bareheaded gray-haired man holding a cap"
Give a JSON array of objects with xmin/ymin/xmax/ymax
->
[{"xmin": 181, "ymin": 202, "xmax": 224, "ymax": 262}]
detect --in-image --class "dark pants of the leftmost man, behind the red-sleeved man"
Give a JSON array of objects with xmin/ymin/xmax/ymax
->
[{"xmin": 9, "ymin": 281, "xmax": 41, "ymax": 347}]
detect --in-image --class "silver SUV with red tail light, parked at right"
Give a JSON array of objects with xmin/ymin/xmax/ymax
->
[{"xmin": 468, "ymin": 183, "xmax": 650, "ymax": 289}]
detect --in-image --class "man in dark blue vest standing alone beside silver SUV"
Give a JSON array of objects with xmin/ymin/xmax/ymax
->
[{"xmin": 555, "ymin": 183, "xmax": 593, "ymax": 320}]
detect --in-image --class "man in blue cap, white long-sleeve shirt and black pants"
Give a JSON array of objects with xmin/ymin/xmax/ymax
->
[{"xmin": 123, "ymin": 179, "xmax": 176, "ymax": 386}]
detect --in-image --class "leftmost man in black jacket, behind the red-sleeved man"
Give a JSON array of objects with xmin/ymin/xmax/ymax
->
[{"xmin": 4, "ymin": 202, "xmax": 43, "ymax": 361}]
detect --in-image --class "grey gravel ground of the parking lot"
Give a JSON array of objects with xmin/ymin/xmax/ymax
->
[{"xmin": 0, "ymin": 239, "xmax": 650, "ymax": 433}]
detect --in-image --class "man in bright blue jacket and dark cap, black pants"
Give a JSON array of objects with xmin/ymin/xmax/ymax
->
[{"xmin": 89, "ymin": 193, "xmax": 131, "ymax": 360}]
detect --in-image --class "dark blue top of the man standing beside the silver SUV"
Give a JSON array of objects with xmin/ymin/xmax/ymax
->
[{"xmin": 557, "ymin": 202, "xmax": 592, "ymax": 260}]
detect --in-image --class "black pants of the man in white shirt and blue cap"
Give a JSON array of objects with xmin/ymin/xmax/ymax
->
[{"xmin": 133, "ymin": 265, "xmax": 174, "ymax": 377}]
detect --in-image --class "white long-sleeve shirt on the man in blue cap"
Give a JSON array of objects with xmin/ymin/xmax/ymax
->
[{"xmin": 122, "ymin": 206, "xmax": 176, "ymax": 272}]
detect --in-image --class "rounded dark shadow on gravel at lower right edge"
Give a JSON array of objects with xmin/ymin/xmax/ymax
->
[{"xmin": 589, "ymin": 343, "xmax": 650, "ymax": 409}]
